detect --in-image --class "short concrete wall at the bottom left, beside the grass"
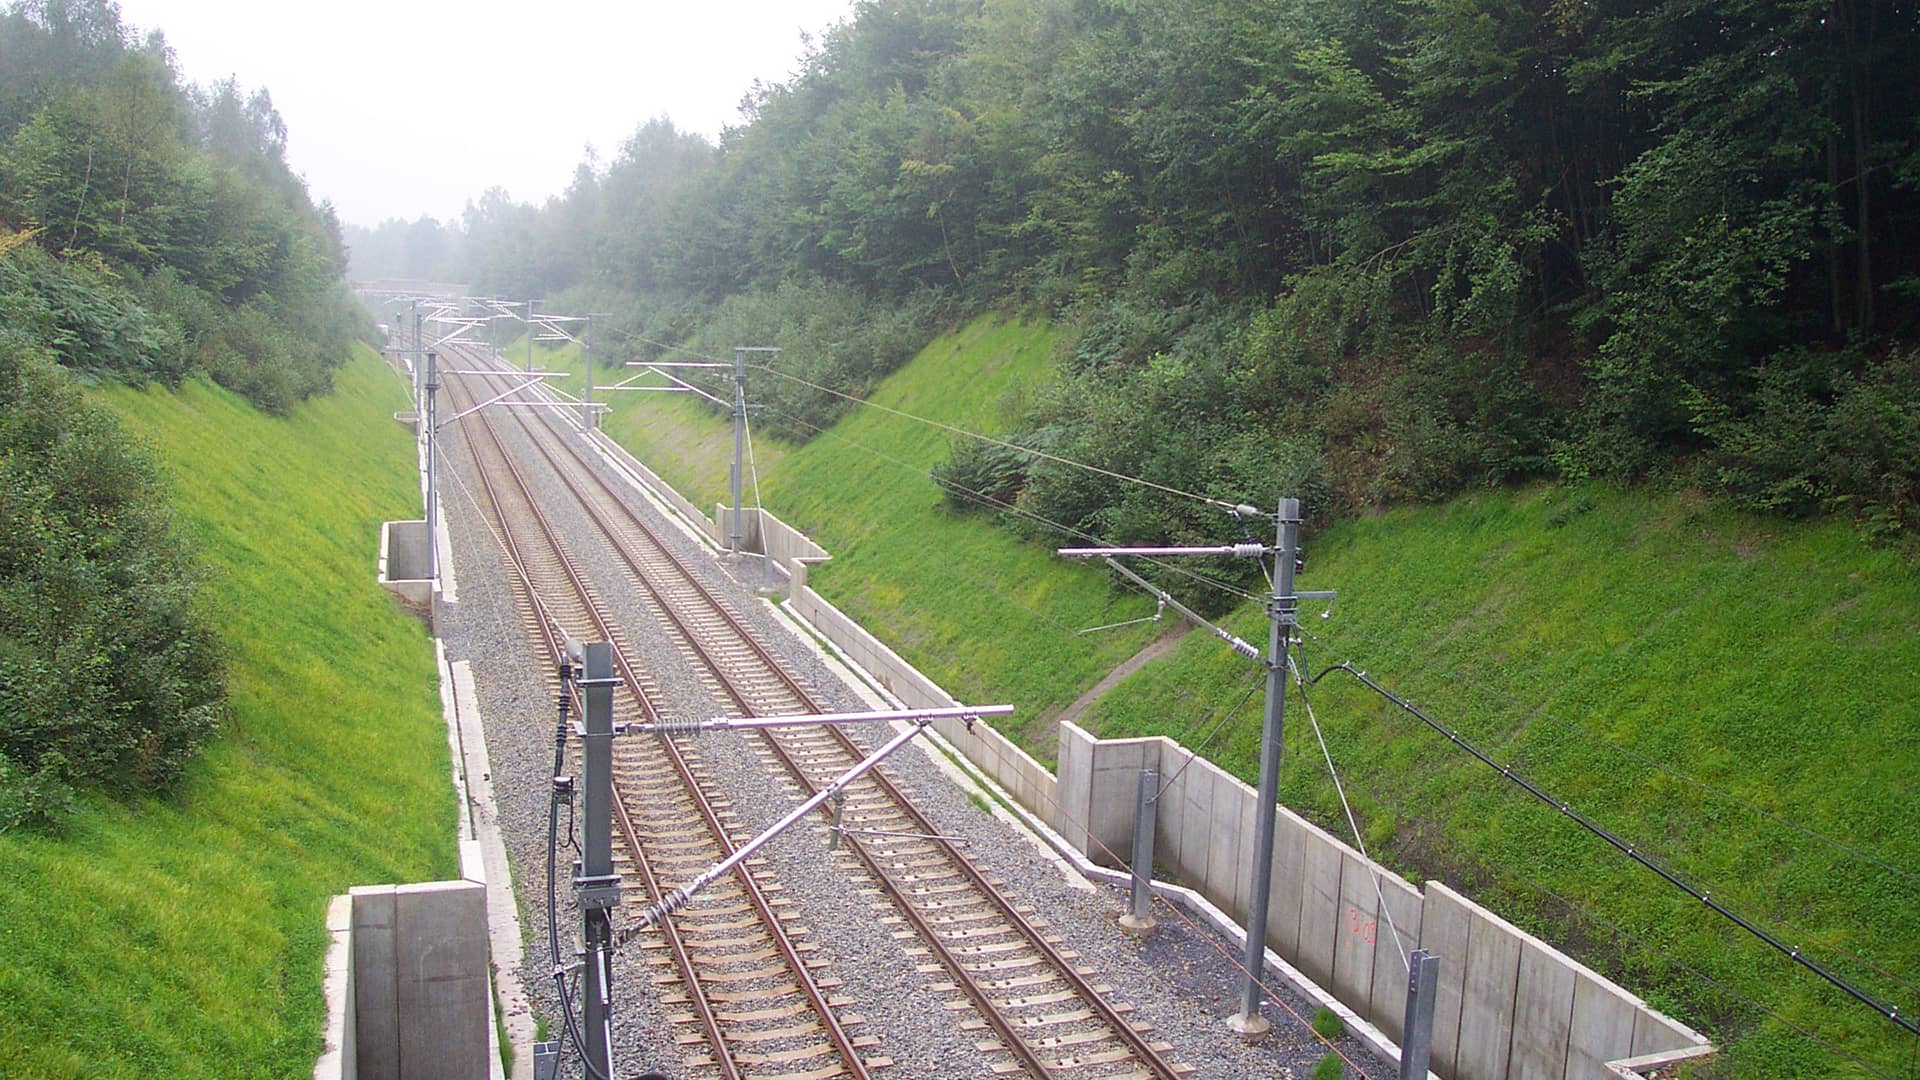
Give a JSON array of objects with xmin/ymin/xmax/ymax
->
[{"xmin": 313, "ymin": 880, "xmax": 487, "ymax": 1080}]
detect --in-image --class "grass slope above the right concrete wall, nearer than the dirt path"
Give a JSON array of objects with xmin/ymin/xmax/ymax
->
[{"xmin": 1089, "ymin": 486, "xmax": 1920, "ymax": 1076}]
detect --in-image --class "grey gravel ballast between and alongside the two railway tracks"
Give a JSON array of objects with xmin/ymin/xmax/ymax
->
[{"xmin": 438, "ymin": 388, "xmax": 1394, "ymax": 1078}]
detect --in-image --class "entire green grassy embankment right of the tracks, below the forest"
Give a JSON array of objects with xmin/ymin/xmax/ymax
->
[{"xmin": 533, "ymin": 315, "xmax": 1920, "ymax": 1078}]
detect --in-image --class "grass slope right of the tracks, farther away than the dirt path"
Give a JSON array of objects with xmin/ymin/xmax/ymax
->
[{"xmin": 556, "ymin": 317, "xmax": 1156, "ymax": 745}]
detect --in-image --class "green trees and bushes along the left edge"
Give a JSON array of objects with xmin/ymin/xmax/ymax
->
[{"xmin": 0, "ymin": 0, "xmax": 372, "ymax": 818}]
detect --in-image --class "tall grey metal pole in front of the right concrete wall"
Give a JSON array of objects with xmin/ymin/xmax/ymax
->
[{"xmin": 1227, "ymin": 500, "xmax": 1300, "ymax": 1038}]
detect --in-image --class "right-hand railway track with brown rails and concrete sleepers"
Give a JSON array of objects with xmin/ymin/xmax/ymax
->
[{"xmin": 439, "ymin": 356, "xmax": 1190, "ymax": 1078}]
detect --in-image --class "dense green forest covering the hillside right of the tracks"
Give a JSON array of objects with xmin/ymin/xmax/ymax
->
[{"xmin": 349, "ymin": 0, "xmax": 1920, "ymax": 591}]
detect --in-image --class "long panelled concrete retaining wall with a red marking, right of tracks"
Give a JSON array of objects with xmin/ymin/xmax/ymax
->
[{"xmin": 1054, "ymin": 724, "xmax": 1711, "ymax": 1080}]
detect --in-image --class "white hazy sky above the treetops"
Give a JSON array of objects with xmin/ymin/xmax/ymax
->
[{"xmin": 108, "ymin": 0, "xmax": 852, "ymax": 225}]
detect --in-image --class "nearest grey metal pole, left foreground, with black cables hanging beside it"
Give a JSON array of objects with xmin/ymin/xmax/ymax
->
[{"xmin": 574, "ymin": 642, "xmax": 620, "ymax": 1078}]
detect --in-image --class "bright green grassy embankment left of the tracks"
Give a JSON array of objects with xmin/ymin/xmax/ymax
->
[{"xmin": 0, "ymin": 350, "xmax": 457, "ymax": 1078}]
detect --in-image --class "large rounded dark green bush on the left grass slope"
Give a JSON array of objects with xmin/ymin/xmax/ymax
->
[{"xmin": 0, "ymin": 332, "xmax": 225, "ymax": 826}]
